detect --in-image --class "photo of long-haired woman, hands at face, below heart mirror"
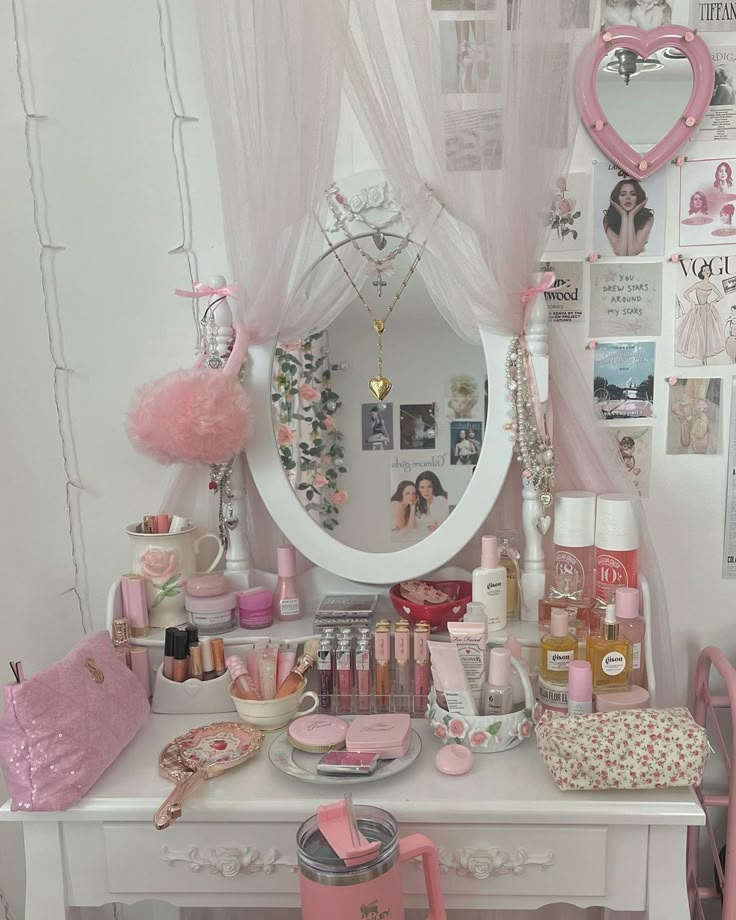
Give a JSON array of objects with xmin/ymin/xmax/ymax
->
[{"xmin": 594, "ymin": 161, "xmax": 666, "ymax": 259}]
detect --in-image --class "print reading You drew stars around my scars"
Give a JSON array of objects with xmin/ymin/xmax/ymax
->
[{"xmin": 588, "ymin": 262, "xmax": 662, "ymax": 337}]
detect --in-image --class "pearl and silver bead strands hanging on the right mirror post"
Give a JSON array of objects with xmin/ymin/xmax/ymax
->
[{"xmin": 506, "ymin": 338, "xmax": 555, "ymax": 509}]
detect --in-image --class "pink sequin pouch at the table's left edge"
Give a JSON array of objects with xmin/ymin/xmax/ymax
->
[{"xmin": 0, "ymin": 632, "xmax": 149, "ymax": 811}]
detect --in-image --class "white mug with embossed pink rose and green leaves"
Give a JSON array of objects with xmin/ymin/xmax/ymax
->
[{"xmin": 125, "ymin": 524, "xmax": 225, "ymax": 627}]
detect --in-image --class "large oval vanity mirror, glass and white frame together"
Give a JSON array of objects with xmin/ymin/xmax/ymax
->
[{"xmin": 248, "ymin": 226, "xmax": 511, "ymax": 584}]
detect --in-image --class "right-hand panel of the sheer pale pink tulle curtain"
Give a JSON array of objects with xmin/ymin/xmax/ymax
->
[{"xmin": 332, "ymin": 0, "xmax": 675, "ymax": 702}]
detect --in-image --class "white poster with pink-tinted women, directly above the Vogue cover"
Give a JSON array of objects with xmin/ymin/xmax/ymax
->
[{"xmin": 679, "ymin": 158, "xmax": 736, "ymax": 246}]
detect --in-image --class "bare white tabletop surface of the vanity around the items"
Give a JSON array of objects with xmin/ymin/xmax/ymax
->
[{"xmin": 0, "ymin": 713, "xmax": 704, "ymax": 825}]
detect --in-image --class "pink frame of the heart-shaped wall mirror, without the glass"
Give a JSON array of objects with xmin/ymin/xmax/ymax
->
[{"xmin": 575, "ymin": 25, "xmax": 715, "ymax": 179}]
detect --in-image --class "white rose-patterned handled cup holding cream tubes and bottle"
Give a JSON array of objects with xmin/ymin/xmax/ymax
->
[{"xmin": 427, "ymin": 658, "xmax": 534, "ymax": 754}]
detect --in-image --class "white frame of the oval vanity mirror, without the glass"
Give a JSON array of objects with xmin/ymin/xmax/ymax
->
[{"xmin": 246, "ymin": 330, "xmax": 512, "ymax": 585}]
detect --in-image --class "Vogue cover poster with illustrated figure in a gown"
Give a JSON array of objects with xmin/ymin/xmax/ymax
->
[{"xmin": 674, "ymin": 253, "xmax": 736, "ymax": 367}]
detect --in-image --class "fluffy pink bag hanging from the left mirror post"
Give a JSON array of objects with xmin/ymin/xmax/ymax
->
[{"xmin": 126, "ymin": 323, "xmax": 253, "ymax": 464}]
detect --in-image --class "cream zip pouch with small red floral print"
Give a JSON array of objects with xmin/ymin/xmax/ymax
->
[{"xmin": 537, "ymin": 709, "xmax": 708, "ymax": 790}]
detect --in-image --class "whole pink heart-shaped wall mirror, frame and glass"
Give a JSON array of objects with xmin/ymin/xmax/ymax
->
[{"xmin": 575, "ymin": 25, "xmax": 714, "ymax": 179}]
